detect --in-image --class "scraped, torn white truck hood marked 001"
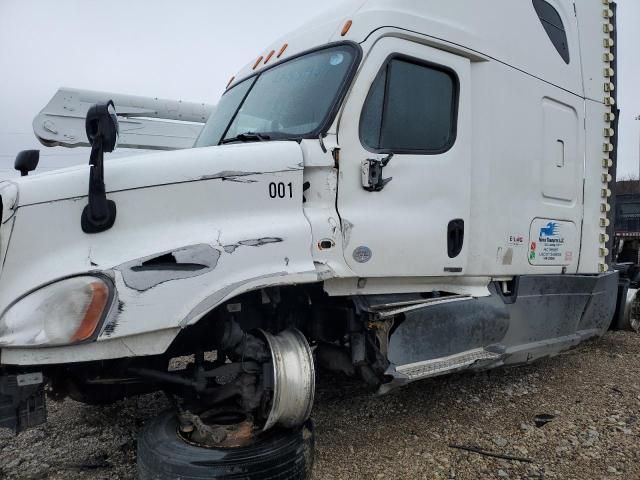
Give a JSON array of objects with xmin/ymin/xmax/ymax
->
[{"xmin": 0, "ymin": 141, "xmax": 318, "ymax": 362}]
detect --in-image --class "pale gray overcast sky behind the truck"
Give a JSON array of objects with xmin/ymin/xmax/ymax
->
[{"xmin": 0, "ymin": 0, "xmax": 640, "ymax": 178}]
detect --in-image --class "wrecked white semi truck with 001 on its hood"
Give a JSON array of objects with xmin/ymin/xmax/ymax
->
[{"xmin": 0, "ymin": 0, "xmax": 619, "ymax": 479}]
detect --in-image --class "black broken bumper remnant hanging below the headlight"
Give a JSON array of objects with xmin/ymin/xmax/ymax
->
[{"xmin": 0, "ymin": 369, "xmax": 47, "ymax": 433}]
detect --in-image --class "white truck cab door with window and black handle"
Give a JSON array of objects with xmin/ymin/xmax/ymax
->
[{"xmin": 338, "ymin": 37, "xmax": 473, "ymax": 277}]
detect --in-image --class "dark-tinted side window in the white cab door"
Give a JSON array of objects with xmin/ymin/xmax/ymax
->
[{"xmin": 360, "ymin": 58, "xmax": 458, "ymax": 154}]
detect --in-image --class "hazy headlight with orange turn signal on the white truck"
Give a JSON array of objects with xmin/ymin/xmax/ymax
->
[{"xmin": 0, "ymin": 276, "xmax": 112, "ymax": 347}]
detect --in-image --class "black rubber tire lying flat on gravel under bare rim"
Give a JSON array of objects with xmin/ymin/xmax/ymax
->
[{"xmin": 138, "ymin": 412, "xmax": 314, "ymax": 480}]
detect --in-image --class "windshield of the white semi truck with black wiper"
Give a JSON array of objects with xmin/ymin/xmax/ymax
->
[{"xmin": 195, "ymin": 45, "xmax": 356, "ymax": 147}]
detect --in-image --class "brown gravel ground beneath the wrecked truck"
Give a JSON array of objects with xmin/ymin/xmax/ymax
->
[{"xmin": 0, "ymin": 332, "xmax": 640, "ymax": 480}]
